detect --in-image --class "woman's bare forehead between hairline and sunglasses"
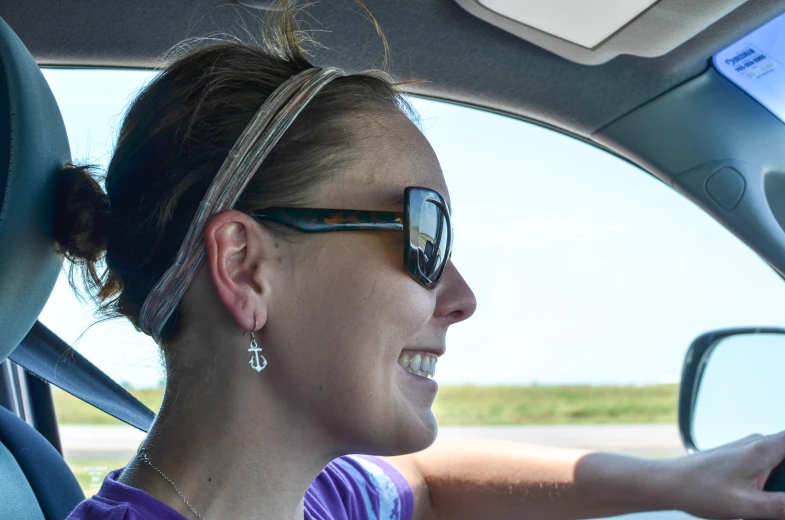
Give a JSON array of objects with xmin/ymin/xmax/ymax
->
[{"xmin": 322, "ymin": 114, "xmax": 450, "ymax": 209}]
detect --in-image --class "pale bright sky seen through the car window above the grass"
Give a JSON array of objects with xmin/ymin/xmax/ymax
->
[{"xmin": 41, "ymin": 69, "xmax": 785, "ymax": 387}]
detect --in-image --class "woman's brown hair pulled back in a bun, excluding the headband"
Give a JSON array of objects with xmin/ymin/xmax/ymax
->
[{"xmin": 55, "ymin": 7, "xmax": 412, "ymax": 341}]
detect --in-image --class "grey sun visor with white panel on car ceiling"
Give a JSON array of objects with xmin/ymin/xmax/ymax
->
[{"xmin": 455, "ymin": 0, "xmax": 747, "ymax": 65}]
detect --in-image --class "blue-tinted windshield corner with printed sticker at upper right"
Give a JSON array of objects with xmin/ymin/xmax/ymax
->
[{"xmin": 714, "ymin": 14, "xmax": 785, "ymax": 121}]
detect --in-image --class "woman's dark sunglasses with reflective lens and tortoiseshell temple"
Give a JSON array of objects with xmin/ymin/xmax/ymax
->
[{"xmin": 252, "ymin": 186, "xmax": 453, "ymax": 289}]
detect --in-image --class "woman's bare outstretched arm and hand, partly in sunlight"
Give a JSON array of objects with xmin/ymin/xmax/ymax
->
[{"xmin": 387, "ymin": 434, "xmax": 785, "ymax": 520}]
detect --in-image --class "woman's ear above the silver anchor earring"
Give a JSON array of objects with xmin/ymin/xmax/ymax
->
[{"xmin": 204, "ymin": 210, "xmax": 275, "ymax": 331}]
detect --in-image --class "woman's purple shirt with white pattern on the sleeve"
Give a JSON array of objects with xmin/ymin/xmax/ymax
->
[{"xmin": 66, "ymin": 455, "xmax": 414, "ymax": 520}]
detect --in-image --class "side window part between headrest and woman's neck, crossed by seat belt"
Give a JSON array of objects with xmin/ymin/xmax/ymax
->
[{"xmin": 40, "ymin": 69, "xmax": 164, "ymax": 496}]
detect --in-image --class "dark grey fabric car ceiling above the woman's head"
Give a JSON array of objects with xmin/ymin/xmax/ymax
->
[{"xmin": 0, "ymin": 0, "xmax": 785, "ymax": 137}]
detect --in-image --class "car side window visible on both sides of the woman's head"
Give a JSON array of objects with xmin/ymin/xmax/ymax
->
[{"xmin": 41, "ymin": 69, "xmax": 785, "ymax": 495}]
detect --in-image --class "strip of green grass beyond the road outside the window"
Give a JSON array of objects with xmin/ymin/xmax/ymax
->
[{"xmin": 53, "ymin": 385, "xmax": 678, "ymax": 426}]
